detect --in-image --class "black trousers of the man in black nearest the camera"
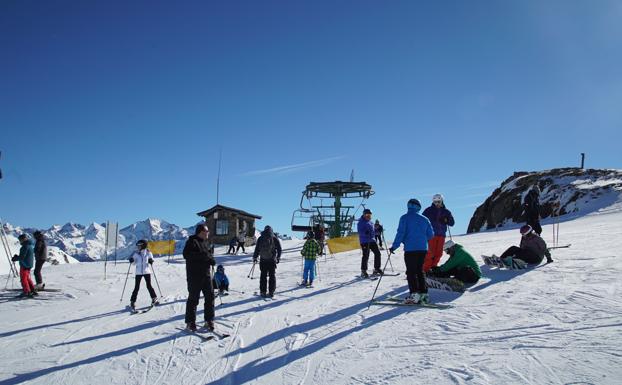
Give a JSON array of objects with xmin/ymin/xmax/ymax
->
[{"xmin": 185, "ymin": 261, "xmax": 214, "ymax": 323}]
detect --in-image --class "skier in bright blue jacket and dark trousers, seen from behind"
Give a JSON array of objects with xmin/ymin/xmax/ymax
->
[{"xmin": 389, "ymin": 198, "xmax": 434, "ymax": 304}]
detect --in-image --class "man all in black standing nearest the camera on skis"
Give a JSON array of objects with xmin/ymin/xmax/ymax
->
[{"xmin": 183, "ymin": 224, "xmax": 216, "ymax": 331}]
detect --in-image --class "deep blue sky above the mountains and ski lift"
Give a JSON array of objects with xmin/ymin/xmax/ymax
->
[{"xmin": 0, "ymin": 0, "xmax": 622, "ymax": 237}]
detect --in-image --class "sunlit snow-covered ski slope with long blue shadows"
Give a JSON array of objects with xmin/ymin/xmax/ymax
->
[{"xmin": 0, "ymin": 212, "xmax": 622, "ymax": 385}]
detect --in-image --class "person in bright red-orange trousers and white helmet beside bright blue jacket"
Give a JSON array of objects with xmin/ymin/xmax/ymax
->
[{"xmin": 423, "ymin": 194, "xmax": 455, "ymax": 273}]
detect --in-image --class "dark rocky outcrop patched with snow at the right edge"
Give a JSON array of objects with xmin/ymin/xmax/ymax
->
[{"xmin": 467, "ymin": 168, "xmax": 622, "ymax": 233}]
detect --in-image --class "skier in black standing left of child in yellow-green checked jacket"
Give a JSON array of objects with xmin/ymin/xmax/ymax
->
[{"xmin": 253, "ymin": 226, "xmax": 281, "ymax": 298}]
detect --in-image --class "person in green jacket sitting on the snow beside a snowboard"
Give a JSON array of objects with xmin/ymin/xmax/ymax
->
[{"xmin": 428, "ymin": 240, "xmax": 482, "ymax": 284}]
